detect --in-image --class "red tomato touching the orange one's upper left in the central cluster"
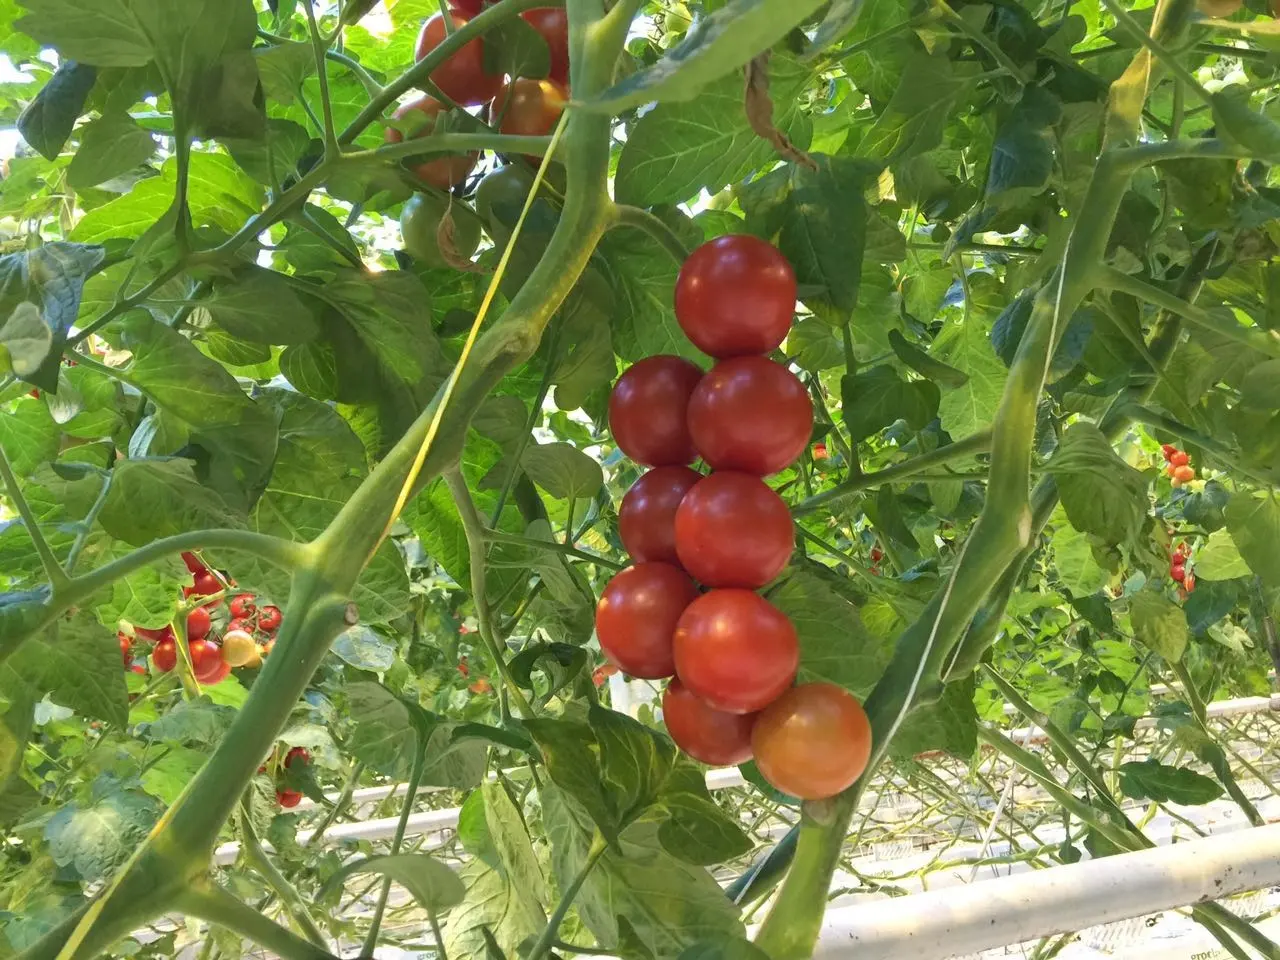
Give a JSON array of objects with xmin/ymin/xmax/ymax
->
[{"xmin": 675, "ymin": 590, "xmax": 800, "ymax": 713}]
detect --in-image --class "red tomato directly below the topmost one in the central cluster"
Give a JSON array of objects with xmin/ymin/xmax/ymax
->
[{"xmin": 689, "ymin": 357, "xmax": 813, "ymax": 476}]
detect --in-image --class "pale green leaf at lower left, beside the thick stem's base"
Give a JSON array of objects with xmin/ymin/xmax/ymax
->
[{"xmin": 45, "ymin": 790, "xmax": 161, "ymax": 883}]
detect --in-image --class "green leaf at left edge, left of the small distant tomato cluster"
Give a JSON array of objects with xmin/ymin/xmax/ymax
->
[{"xmin": 0, "ymin": 611, "xmax": 129, "ymax": 727}]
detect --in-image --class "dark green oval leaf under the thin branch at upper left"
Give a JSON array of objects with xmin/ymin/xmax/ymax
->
[{"xmin": 204, "ymin": 266, "xmax": 320, "ymax": 344}]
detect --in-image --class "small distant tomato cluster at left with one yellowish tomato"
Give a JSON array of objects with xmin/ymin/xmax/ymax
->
[{"xmin": 118, "ymin": 553, "xmax": 283, "ymax": 686}]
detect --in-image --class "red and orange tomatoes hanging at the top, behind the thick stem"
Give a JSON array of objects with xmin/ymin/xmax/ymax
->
[{"xmin": 387, "ymin": 0, "xmax": 568, "ymax": 189}]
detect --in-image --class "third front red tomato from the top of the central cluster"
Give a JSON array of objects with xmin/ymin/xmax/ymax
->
[{"xmin": 676, "ymin": 470, "xmax": 795, "ymax": 590}]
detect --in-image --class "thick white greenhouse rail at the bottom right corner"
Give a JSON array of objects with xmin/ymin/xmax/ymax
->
[{"xmin": 814, "ymin": 824, "xmax": 1280, "ymax": 960}]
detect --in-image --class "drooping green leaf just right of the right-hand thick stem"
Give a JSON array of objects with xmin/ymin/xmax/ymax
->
[{"xmin": 1046, "ymin": 421, "xmax": 1148, "ymax": 544}]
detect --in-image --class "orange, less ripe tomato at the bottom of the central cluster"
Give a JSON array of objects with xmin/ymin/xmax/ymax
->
[{"xmin": 751, "ymin": 684, "xmax": 872, "ymax": 800}]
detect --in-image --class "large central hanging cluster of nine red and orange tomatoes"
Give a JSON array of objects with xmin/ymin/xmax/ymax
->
[{"xmin": 595, "ymin": 236, "xmax": 870, "ymax": 799}]
